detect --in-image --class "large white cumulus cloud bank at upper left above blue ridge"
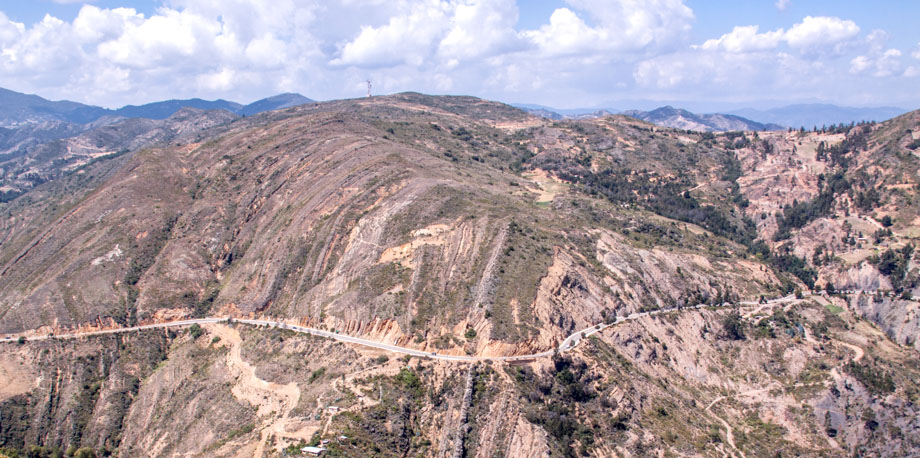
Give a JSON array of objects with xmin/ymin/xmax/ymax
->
[{"xmin": 0, "ymin": 0, "xmax": 322, "ymax": 105}]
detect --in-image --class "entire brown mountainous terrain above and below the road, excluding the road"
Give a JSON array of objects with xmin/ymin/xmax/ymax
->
[{"xmin": 0, "ymin": 93, "xmax": 920, "ymax": 457}]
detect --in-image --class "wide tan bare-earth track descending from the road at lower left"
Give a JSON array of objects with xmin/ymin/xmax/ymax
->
[{"xmin": 207, "ymin": 324, "xmax": 316, "ymax": 458}]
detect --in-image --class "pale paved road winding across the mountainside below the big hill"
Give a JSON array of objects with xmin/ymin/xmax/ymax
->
[{"xmin": 3, "ymin": 295, "xmax": 820, "ymax": 362}]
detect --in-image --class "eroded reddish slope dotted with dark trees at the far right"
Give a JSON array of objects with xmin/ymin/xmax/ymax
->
[{"xmin": 724, "ymin": 112, "xmax": 920, "ymax": 348}]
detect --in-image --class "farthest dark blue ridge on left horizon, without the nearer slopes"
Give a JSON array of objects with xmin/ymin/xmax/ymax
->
[{"xmin": 0, "ymin": 88, "xmax": 314, "ymax": 127}]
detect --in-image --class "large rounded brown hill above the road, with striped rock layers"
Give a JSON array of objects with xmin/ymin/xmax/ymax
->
[{"xmin": 0, "ymin": 95, "xmax": 778, "ymax": 344}]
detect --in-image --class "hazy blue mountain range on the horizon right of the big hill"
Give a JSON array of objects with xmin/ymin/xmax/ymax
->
[{"xmin": 513, "ymin": 104, "xmax": 908, "ymax": 132}]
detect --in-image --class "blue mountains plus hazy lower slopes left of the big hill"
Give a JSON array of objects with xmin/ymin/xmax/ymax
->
[{"xmin": 0, "ymin": 89, "xmax": 313, "ymax": 202}]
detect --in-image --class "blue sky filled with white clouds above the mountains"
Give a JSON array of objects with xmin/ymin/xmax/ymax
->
[{"xmin": 0, "ymin": 0, "xmax": 920, "ymax": 111}]
